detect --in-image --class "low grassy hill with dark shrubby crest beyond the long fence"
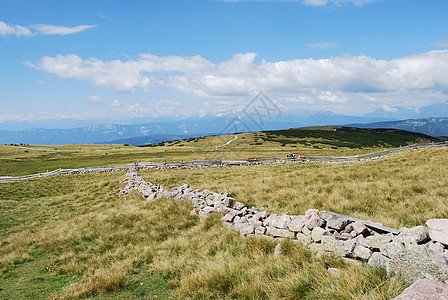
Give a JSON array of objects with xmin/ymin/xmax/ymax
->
[{"xmin": 0, "ymin": 127, "xmax": 437, "ymax": 176}]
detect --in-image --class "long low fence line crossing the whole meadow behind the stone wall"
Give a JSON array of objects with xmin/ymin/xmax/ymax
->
[{"xmin": 0, "ymin": 141, "xmax": 448, "ymax": 183}]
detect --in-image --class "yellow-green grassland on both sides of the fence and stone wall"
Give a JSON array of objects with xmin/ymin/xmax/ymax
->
[{"xmin": 0, "ymin": 128, "xmax": 448, "ymax": 299}]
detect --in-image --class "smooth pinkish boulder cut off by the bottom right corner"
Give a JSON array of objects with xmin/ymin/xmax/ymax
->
[{"xmin": 392, "ymin": 279, "xmax": 448, "ymax": 300}]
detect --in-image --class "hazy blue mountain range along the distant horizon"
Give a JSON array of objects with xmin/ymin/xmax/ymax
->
[{"xmin": 0, "ymin": 111, "xmax": 448, "ymax": 145}]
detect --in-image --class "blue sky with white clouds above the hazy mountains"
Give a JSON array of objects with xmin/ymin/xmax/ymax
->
[{"xmin": 0, "ymin": 0, "xmax": 448, "ymax": 129}]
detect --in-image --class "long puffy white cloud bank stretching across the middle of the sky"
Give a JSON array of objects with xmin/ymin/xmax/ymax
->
[{"xmin": 27, "ymin": 50, "xmax": 448, "ymax": 99}]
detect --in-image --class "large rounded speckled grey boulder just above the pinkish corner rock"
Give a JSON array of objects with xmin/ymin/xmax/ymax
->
[{"xmin": 388, "ymin": 245, "xmax": 448, "ymax": 283}]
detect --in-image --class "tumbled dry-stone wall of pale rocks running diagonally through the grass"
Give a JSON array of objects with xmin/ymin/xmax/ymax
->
[{"xmin": 119, "ymin": 171, "xmax": 448, "ymax": 283}]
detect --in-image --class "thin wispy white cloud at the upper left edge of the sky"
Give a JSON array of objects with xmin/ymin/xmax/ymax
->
[{"xmin": 0, "ymin": 21, "xmax": 96, "ymax": 37}]
